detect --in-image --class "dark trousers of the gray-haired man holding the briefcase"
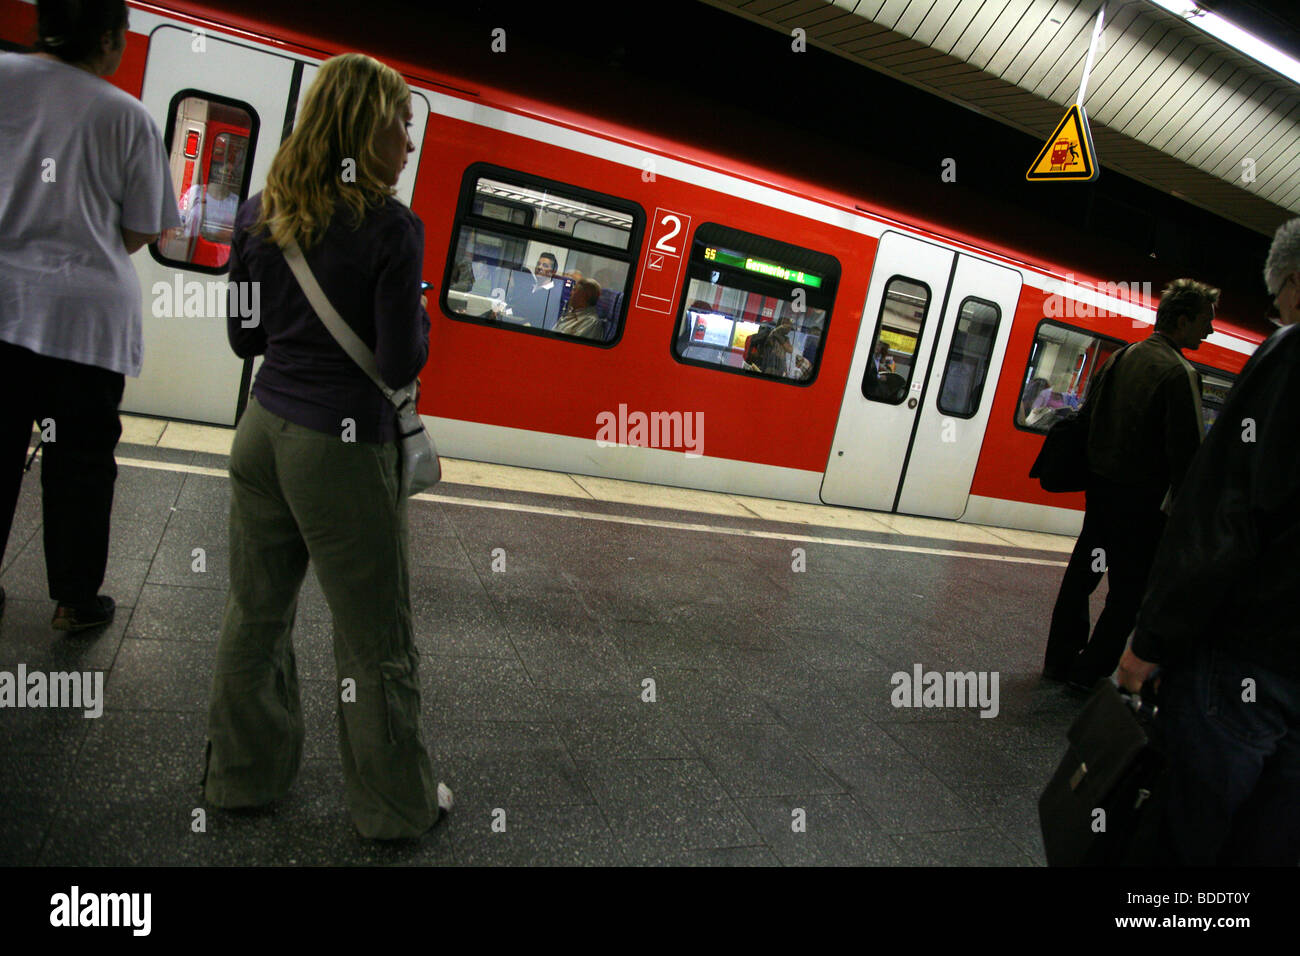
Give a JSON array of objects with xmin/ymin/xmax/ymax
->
[{"xmin": 1157, "ymin": 642, "xmax": 1300, "ymax": 866}]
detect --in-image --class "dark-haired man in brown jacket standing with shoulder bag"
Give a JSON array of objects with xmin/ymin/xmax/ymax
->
[{"xmin": 1043, "ymin": 278, "xmax": 1219, "ymax": 689}]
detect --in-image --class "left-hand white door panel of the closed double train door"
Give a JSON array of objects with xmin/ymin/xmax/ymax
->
[{"xmin": 822, "ymin": 232, "xmax": 954, "ymax": 511}]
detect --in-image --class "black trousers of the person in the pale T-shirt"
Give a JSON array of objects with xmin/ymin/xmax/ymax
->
[{"xmin": 0, "ymin": 342, "xmax": 126, "ymax": 604}]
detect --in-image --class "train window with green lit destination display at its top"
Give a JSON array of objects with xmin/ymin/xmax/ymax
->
[{"xmin": 673, "ymin": 222, "xmax": 840, "ymax": 384}]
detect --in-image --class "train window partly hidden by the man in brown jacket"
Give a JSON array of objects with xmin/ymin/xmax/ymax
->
[{"xmin": 1015, "ymin": 323, "xmax": 1125, "ymax": 432}]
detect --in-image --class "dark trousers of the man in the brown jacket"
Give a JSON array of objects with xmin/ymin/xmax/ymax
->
[{"xmin": 1044, "ymin": 477, "xmax": 1165, "ymax": 684}]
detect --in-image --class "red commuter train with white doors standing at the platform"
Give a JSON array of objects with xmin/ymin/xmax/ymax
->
[{"xmin": 0, "ymin": 0, "xmax": 1261, "ymax": 533}]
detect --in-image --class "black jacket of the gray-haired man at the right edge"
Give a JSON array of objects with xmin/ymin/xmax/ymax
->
[{"xmin": 1132, "ymin": 325, "xmax": 1300, "ymax": 678}]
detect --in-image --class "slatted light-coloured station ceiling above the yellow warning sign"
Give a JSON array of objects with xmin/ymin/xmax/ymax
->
[{"xmin": 703, "ymin": 0, "xmax": 1300, "ymax": 235}]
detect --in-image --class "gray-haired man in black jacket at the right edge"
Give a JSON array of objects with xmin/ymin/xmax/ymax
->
[{"xmin": 1115, "ymin": 219, "xmax": 1300, "ymax": 866}]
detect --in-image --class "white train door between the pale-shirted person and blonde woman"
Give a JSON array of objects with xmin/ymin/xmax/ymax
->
[{"xmin": 122, "ymin": 26, "xmax": 295, "ymax": 424}]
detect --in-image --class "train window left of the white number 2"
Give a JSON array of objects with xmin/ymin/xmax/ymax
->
[{"xmin": 442, "ymin": 165, "xmax": 645, "ymax": 343}]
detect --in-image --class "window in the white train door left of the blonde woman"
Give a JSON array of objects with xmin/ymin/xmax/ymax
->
[{"xmin": 155, "ymin": 90, "xmax": 257, "ymax": 272}]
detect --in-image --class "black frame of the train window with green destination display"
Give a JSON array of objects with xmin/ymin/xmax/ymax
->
[{"xmin": 668, "ymin": 221, "xmax": 844, "ymax": 388}]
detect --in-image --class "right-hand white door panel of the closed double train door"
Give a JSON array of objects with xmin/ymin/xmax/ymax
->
[{"xmin": 894, "ymin": 255, "xmax": 1021, "ymax": 518}]
